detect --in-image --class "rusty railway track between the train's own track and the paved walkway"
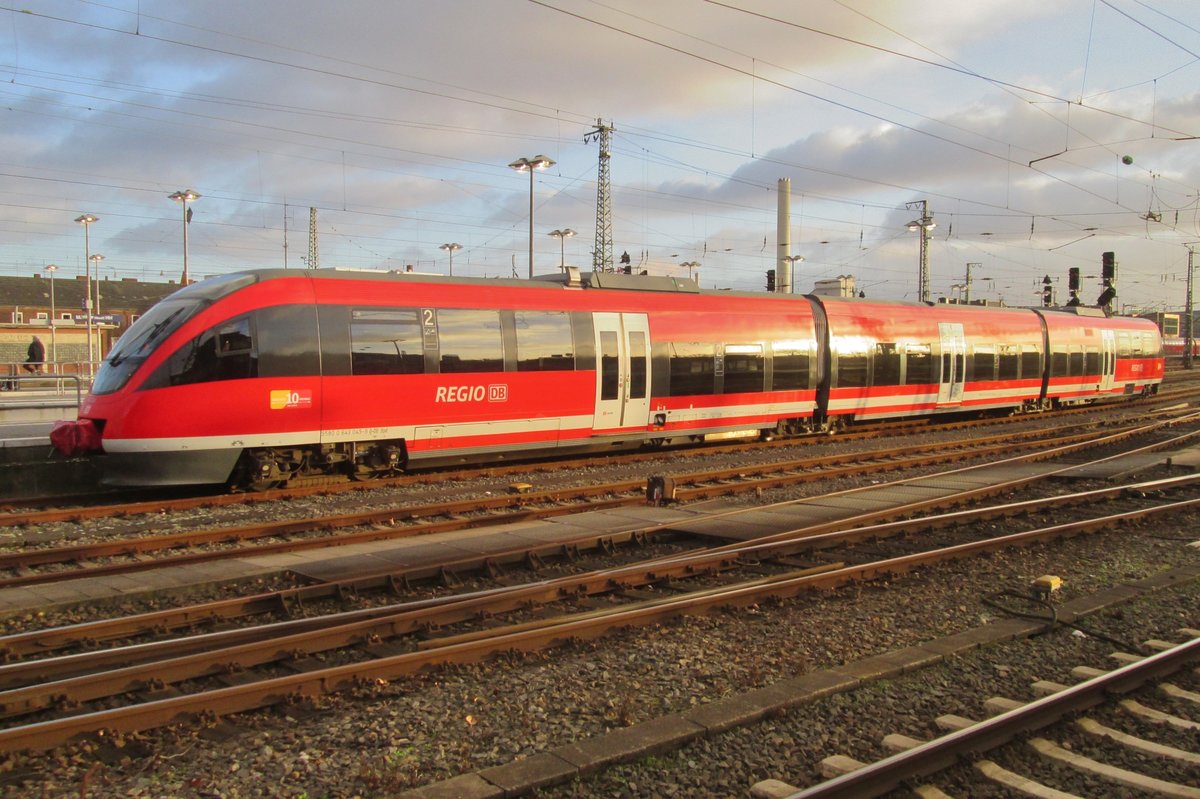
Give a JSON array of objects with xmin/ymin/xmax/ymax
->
[{"xmin": 0, "ymin": 407, "xmax": 1189, "ymax": 588}]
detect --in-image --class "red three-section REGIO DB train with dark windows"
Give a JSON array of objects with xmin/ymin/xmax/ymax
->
[{"xmin": 52, "ymin": 269, "xmax": 1163, "ymax": 488}]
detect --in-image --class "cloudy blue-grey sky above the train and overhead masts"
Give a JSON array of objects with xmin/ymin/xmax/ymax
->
[{"xmin": 0, "ymin": 0, "xmax": 1200, "ymax": 310}]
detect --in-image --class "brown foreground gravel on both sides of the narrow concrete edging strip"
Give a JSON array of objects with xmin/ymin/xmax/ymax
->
[{"xmin": 0, "ymin": 410, "xmax": 1200, "ymax": 799}]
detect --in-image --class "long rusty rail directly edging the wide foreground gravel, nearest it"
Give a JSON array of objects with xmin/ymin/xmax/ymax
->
[{"xmin": 0, "ymin": 482, "xmax": 1200, "ymax": 751}]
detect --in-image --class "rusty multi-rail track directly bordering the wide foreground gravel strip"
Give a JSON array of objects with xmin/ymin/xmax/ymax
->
[{"xmin": 0, "ymin": 448, "xmax": 1200, "ymax": 753}]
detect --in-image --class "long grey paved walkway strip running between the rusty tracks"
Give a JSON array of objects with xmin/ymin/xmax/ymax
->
[{"xmin": 0, "ymin": 447, "xmax": 1200, "ymax": 617}]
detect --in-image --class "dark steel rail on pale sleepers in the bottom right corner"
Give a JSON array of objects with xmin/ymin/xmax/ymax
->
[{"xmin": 787, "ymin": 638, "xmax": 1200, "ymax": 799}]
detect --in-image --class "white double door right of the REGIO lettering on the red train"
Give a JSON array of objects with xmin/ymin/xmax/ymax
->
[{"xmin": 593, "ymin": 313, "xmax": 650, "ymax": 432}]
